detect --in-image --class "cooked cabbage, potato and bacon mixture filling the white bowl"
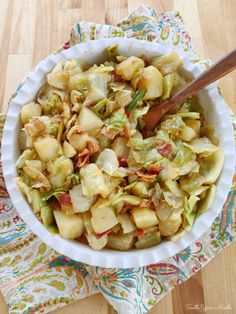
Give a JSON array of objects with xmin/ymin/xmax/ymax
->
[{"xmin": 16, "ymin": 45, "xmax": 224, "ymax": 250}]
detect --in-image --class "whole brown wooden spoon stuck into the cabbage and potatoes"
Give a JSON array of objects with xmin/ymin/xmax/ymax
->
[{"xmin": 143, "ymin": 49, "xmax": 236, "ymax": 130}]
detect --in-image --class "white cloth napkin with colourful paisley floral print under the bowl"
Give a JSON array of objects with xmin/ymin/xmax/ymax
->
[{"xmin": 0, "ymin": 5, "xmax": 236, "ymax": 314}]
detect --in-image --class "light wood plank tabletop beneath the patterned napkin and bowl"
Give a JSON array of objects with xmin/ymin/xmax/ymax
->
[{"xmin": 0, "ymin": 0, "xmax": 236, "ymax": 314}]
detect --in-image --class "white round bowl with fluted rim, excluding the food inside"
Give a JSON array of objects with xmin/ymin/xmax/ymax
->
[{"xmin": 2, "ymin": 38, "xmax": 235, "ymax": 268}]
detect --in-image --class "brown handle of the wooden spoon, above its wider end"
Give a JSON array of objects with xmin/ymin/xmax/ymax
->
[{"xmin": 171, "ymin": 49, "xmax": 236, "ymax": 104}]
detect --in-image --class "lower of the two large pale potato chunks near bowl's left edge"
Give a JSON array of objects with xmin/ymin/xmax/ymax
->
[{"xmin": 34, "ymin": 137, "xmax": 60, "ymax": 162}]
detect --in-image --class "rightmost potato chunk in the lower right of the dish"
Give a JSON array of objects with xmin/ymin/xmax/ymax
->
[{"xmin": 159, "ymin": 211, "xmax": 182, "ymax": 236}]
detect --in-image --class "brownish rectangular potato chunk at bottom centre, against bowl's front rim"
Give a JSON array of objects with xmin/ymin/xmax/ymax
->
[{"xmin": 107, "ymin": 233, "xmax": 134, "ymax": 251}]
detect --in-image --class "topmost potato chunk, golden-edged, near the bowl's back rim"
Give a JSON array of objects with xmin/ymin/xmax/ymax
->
[{"xmin": 116, "ymin": 56, "xmax": 144, "ymax": 81}]
